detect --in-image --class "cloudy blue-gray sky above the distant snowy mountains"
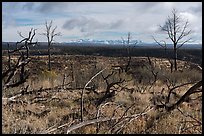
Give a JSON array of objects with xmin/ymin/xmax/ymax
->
[{"xmin": 2, "ymin": 2, "xmax": 202, "ymax": 43}]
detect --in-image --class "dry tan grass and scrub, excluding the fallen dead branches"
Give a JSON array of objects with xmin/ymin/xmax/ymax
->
[{"xmin": 2, "ymin": 56, "xmax": 202, "ymax": 134}]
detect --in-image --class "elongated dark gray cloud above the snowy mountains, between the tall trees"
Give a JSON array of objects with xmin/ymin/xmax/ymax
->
[{"xmin": 62, "ymin": 16, "xmax": 123, "ymax": 32}]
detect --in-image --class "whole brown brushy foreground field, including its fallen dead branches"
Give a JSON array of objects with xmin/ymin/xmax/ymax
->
[{"xmin": 2, "ymin": 55, "xmax": 202, "ymax": 134}]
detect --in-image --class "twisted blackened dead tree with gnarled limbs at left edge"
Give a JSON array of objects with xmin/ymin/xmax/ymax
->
[{"xmin": 2, "ymin": 29, "xmax": 37, "ymax": 89}]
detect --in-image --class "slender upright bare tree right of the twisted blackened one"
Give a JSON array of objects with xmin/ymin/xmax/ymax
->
[{"xmin": 42, "ymin": 21, "xmax": 61, "ymax": 71}]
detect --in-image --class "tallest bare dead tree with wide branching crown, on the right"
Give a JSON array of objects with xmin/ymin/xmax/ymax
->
[{"xmin": 155, "ymin": 9, "xmax": 192, "ymax": 71}]
